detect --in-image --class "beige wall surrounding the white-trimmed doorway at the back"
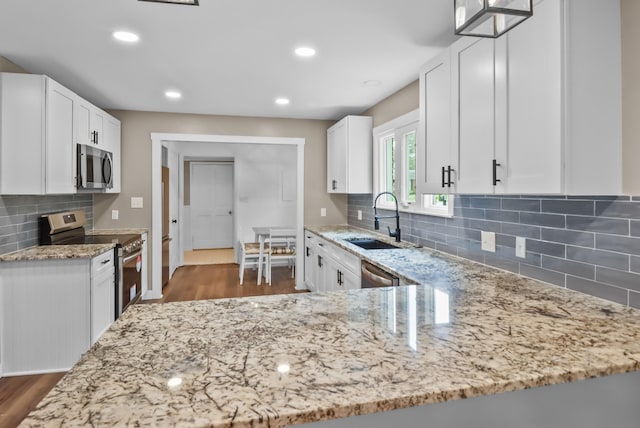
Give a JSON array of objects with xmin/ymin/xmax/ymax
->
[{"xmin": 93, "ymin": 110, "xmax": 347, "ymax": 234}]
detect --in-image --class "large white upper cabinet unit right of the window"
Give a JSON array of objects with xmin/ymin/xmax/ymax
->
[{"xmin": 418, "ymin": 0, "xmax": 622, "ymax": 194}]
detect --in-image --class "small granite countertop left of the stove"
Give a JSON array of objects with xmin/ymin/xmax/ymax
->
[{"xmin": 0, "ymin": 244, "xmax": 115, "ymax": 262}]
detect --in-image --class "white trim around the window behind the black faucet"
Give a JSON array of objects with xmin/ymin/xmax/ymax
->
[{"xmin": 372, "ymin": 109, "xmax": 454, "ymax": 218}]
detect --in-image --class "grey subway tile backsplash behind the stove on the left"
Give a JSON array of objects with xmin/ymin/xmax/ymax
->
[{"xmin": 0, "ymin": 194, "xmax": 93, "ymax": 254}]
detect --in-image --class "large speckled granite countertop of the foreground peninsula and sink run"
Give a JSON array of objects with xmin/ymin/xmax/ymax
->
[{"xmin": 23, "ymin": 228, "xmax": 640, "ymax": 427}]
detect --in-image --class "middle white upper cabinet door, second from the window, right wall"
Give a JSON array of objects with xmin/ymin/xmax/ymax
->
[{"xmin": 451, "ymin": 38, "xmax": 495, "ymax": 193}]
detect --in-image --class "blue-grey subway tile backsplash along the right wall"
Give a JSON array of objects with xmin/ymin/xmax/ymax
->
[{"xmin": 350, "ymin": 195, "xmax": 640, "ymax": 308}]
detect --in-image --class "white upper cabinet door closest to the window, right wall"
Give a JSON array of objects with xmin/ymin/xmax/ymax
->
[{"xmin": 416, "ymin": 49, "xmax": 458, "ymax": 195}]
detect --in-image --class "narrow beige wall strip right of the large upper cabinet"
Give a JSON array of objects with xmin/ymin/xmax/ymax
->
[{"xmin": 620, "ymin": 0, "xmax": 640, "ymax": 195}]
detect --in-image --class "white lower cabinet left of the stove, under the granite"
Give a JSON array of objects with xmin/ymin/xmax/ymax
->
[{"xmin": 0, "ymin": 251, "xmax": 115, "ymax": 376}]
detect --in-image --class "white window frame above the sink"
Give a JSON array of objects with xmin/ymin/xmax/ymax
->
[{"xmin": 372, "ymin": 110, "xmax": 454, "ymax": 218}]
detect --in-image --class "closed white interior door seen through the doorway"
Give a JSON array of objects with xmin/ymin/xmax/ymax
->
[{"xmin": 191, "ymin": 162, "xmax": 233, "ymax": 250}]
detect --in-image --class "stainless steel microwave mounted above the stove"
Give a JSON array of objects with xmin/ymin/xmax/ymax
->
[{"xmin": 77, "ymin": 144, "xmax": 113, "ymax": 189}]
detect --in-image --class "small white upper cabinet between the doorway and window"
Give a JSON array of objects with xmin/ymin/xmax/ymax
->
[{"xmin": 327, "ymin": 116, "xmax": 373, "ymax": 193}]
